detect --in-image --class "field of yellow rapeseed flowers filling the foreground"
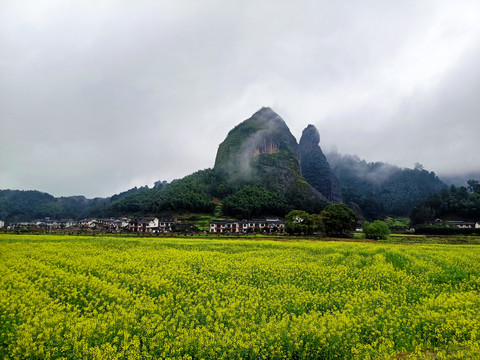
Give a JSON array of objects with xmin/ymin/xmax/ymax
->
[{"xmin": 0, "ymin": 235, "xmax": 480, "ymax": 359}]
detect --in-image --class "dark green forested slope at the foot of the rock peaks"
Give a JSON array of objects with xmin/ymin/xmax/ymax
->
[{"xmin": 98, "ymin": 169, "xmax": 325, "ymax": 218}]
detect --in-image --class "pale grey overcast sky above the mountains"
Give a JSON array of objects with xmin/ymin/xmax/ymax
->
[{"xmin": 0, "ymin": 0, "xmax": 480, "ymax": 197}]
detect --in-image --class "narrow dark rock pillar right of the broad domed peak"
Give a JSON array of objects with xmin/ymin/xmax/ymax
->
[{"xmin": 299, "ymin": 125, "xmax": 343, "ymax": 202}]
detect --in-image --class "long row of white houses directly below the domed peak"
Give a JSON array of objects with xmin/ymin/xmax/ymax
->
[{"xmin": 210, "ymin": 218, "xmax": 285, "ymax": 234}]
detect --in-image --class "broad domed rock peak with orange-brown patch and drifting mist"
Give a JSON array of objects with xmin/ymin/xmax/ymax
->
[{"xmin": 215, "ymin": 108, "xmax": 326, "ymax": 200}]
